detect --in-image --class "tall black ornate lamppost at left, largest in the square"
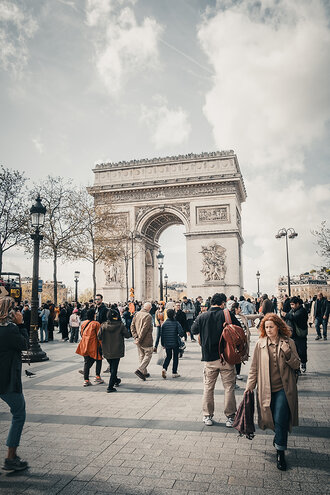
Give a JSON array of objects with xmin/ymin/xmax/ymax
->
[{"xmin": 22, "ymin": 194, "xmax": 49, "ymax": 363}]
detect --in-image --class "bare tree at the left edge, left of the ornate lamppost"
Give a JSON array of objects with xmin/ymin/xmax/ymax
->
[{"xmin": 0, "ymin": 165, "xmax": 29, "ymax": 272}]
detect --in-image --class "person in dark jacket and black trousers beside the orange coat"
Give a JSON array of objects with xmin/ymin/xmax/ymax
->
[{"xmin": 98, "ymin": 308, "xmax": 131, "ymax": 393}]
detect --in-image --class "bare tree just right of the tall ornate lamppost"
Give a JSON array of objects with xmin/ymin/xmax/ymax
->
[{"xmin": 28, "ymin": 176, "xmax": 81, "ymax": 305}]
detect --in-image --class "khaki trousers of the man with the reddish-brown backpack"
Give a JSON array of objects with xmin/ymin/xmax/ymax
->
[{"xmin": 203, "ymin": 359, "xmax": 236, "ymax": 417}]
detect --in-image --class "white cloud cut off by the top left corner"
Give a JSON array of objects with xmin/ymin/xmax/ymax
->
[{"xmin": 0, "ymin": 1, "xmax": 38, "ymax": 77}]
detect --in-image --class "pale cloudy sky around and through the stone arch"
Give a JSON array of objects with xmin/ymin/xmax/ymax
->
[{"xmin": 0, "ymin": 0, "xmax": 330, "ymax": 293}]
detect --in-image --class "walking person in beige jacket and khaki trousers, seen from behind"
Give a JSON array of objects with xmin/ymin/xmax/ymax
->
[{"xmin": 131, "ymin": 302, "xmax": 153, "ymax": 381}]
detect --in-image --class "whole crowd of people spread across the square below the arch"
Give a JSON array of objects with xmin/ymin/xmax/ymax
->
[{"xmin": 0, "ymin": 293, "xmax": 329, "ymax": 470}]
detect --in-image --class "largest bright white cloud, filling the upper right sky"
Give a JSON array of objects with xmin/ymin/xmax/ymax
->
[{"xmin": 198, "ymin": 0, "xmax": 330, "ymax": 170}]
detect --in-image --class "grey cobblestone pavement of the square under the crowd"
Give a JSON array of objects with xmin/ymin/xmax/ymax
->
[{"xmin": 0, "ymin": 329, "xmax": 330, "ymax": 495}]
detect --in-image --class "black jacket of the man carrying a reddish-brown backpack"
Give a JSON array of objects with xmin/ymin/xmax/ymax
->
[{"xmin": 191, "ymin": 306, "xmax": 241, "ymax": 361}]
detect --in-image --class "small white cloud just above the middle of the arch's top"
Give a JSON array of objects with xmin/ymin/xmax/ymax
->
[{"xmin": 140, "ymin": 97, "xmax": 191, "ymax": 149}]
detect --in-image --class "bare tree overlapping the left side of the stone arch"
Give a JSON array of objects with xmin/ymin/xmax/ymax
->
[{"xmin": 72, "ymin": 188, "xmax": 126, "ymax": 296}]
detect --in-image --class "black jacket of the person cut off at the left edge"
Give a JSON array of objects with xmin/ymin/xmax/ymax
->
[{"xmin": 0, "ymin": 323, "xmax": 29, "ymax": 394}]
